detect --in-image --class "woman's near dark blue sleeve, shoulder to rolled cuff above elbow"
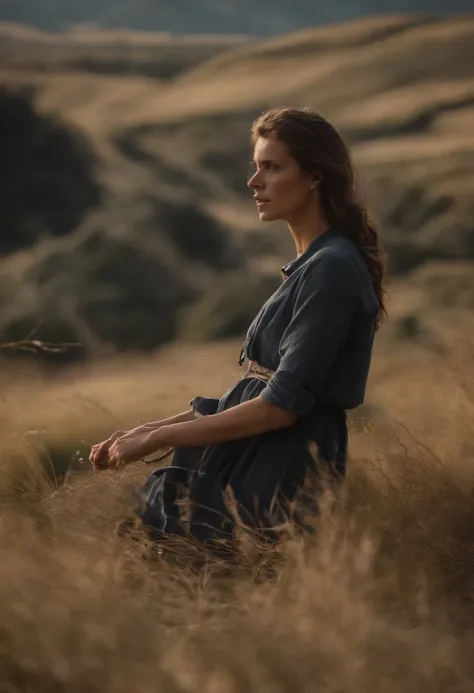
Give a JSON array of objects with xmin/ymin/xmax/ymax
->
[{"xmin": 261, "ymin": 250, "xmax": 360, "ymax": 416}]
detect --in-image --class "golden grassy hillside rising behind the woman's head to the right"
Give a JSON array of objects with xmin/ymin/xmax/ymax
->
[{"xmin": 101, "ymin": 15, "xmax": 474, "ymax": 272}]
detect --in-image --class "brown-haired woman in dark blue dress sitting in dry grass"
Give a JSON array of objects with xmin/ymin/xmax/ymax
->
[{"xmin": 91, "ymin": 109, "xmax": 385, "ymax": 542}]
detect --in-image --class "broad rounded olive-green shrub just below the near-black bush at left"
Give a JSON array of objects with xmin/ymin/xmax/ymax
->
[{"xmin": 0, "ymin": 232, "xmax": 196, "ymax": 361}]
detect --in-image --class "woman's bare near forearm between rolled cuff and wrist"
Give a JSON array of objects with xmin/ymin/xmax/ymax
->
[{"xmin": 151, "ymin": 397, "xmax": 297, "ymax": 449}]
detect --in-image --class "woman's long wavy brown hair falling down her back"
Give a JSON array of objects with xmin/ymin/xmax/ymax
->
[{"xmin": 252, "ymin": 108, "xmax": 387, "ymax": 320}]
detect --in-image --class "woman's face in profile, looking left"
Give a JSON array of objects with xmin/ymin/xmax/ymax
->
[{"xmin": 247, "ymin": 137, "xmax": 316, "ymax": 222}]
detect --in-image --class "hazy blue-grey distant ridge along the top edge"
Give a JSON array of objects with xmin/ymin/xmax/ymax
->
[{"xmin": 0, "ymin": 0, "xmax": 472, "ymax": 35}]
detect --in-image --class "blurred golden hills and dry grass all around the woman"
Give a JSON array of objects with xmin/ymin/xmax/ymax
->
[{"xmin": 0, "ymin": 5, "xmax": 474, "ymax": 693}]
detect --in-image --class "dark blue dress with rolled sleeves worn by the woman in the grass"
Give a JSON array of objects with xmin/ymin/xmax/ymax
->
[{"xmin": 139, "ymin": 228, "xmax": 379, "ymax": 542}]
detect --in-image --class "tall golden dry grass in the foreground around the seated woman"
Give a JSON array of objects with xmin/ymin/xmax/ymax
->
[{"xmin": 0, "ymin": 338, "xmax": 474, "ymax": 693}]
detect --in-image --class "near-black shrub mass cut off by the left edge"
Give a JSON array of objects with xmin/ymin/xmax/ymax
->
[{"xmin": 0, "ymin": 87, "xmax": 100, "ymax": 254}]
